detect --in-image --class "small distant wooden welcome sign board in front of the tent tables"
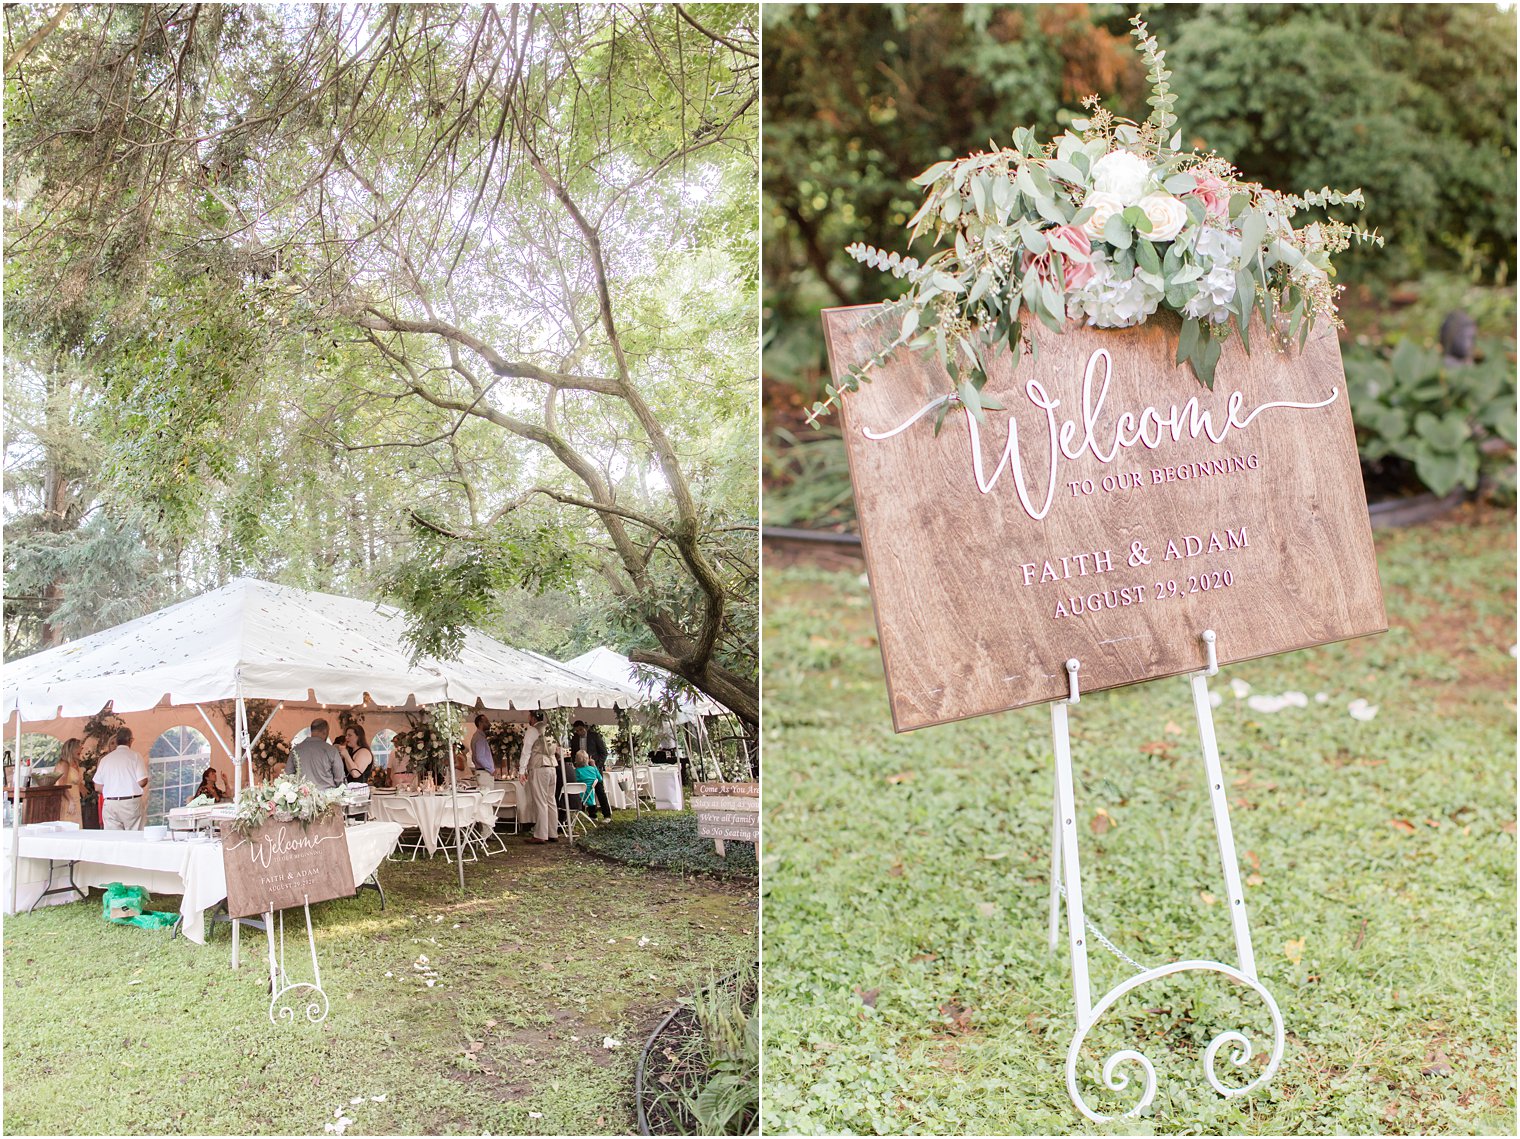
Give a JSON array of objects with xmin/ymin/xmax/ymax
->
[{"xmin": 222, "ymin": 814, "xmax": 354, "ymax": 917}]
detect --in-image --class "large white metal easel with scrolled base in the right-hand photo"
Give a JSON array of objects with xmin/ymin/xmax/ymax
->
[{"xmin": 1050, "ymin": 630, "xmax": 1283, "ymax": 1122}]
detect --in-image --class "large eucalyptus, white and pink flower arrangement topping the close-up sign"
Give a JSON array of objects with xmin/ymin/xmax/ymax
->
[{"xmin": 809, "ymin": 15, "xmax": 1382, "ymax": 432}]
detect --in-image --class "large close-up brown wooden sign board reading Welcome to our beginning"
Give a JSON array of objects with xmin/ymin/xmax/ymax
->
[{"xmin": 824, "ymin": 306, "xmax": 1388, "ymax": 731}]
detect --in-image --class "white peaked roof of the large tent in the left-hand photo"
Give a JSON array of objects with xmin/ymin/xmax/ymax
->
[{"xmin": 5, "ymin": 578, "xmax": 629, "ymax": 721}]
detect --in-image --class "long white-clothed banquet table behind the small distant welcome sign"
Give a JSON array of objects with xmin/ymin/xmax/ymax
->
[{"xmin": 3, "ymin": 821, "xmax": 401, "ymax": 944}]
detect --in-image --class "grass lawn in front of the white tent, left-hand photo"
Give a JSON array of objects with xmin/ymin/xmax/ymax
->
[{"xmin": 5, "ymin": 815, "xmax": 757, "ymax": 1134}]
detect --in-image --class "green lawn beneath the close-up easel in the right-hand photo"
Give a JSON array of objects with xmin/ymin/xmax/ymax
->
[{"xmin": 762, "ymin": 509, "xmax": 1515, "ymax": 1134}]
